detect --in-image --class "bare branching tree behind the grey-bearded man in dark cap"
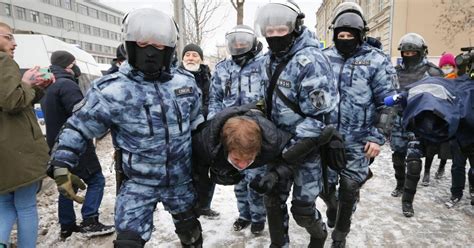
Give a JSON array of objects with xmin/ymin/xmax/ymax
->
[{"xmin": 184, "ymin": 0, "xmax": 223, "ymax": 46}]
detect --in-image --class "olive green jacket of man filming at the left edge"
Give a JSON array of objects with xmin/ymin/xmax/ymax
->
[{"xmin": 0, "ymin": 52, "xmax": 49, "ymax": 194}]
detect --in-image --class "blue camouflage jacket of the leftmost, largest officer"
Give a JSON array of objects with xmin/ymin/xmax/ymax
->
[{"xmin": 51, "ymin": 62, "xmax": 204, "ymax": 187}]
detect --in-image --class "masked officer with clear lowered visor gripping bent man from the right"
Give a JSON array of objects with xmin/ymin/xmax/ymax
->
[{"xmin": 255, "ymin": 1, "xmax": 338, "ymax": 247}]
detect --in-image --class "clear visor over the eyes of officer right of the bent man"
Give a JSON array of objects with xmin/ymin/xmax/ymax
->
[{"xmin": 255, "ymin": 3, "xmax": 298, "ymax": 37}]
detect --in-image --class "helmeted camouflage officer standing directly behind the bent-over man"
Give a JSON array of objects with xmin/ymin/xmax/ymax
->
[{"xmin": 208, "ymin": 25, "xmax": 266, "ymax": 234}]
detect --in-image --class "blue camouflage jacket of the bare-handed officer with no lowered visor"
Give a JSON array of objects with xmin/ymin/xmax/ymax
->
[{"xmin": 323, "ymin": 43, "xmax": 398, "ymax": 145}]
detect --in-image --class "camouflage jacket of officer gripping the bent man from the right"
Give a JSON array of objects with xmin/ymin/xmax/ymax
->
[{"xmin": 261, "ymin": 27, "xmax": 339, "ymax": 141}]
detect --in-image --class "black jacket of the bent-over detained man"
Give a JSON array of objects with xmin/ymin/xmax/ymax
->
[{"xmin": 193, "ymin": 105, "xmax": 292, "ymax": 184}]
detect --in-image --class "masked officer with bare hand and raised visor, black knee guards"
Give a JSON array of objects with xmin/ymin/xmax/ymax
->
[{"xmin": 321, "ymin": 8, "xmax": 398, "ymax": 247}]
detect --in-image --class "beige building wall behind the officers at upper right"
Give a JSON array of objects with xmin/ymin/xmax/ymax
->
[{"xmin": 316, "ymin": 0, "xmax": 474, "ymax": 61}]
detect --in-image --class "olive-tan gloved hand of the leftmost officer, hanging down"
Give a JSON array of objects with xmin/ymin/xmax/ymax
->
[{"xmin": 54, "ymin": 168, "xmax": 86, "ymax": 203}]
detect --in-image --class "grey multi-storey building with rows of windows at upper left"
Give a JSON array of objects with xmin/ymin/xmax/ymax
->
[{"xmin": 0, "ymin": 0, "xmax": 124, "ymax": 63}]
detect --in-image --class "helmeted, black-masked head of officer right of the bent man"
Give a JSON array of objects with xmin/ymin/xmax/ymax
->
[{"xmin": 255, "ymin": 1, "xmax": 304, "ymax": 56}]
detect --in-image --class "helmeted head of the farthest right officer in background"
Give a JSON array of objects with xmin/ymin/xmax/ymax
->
[{"xmin": 398, "ymin": 33, "xmax": 428, "ymax": 68}]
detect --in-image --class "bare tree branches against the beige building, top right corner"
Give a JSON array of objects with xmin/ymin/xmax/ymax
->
[{"xmin": 435, "ymin": 0, "xmax": 474, "ymax": 47}]
